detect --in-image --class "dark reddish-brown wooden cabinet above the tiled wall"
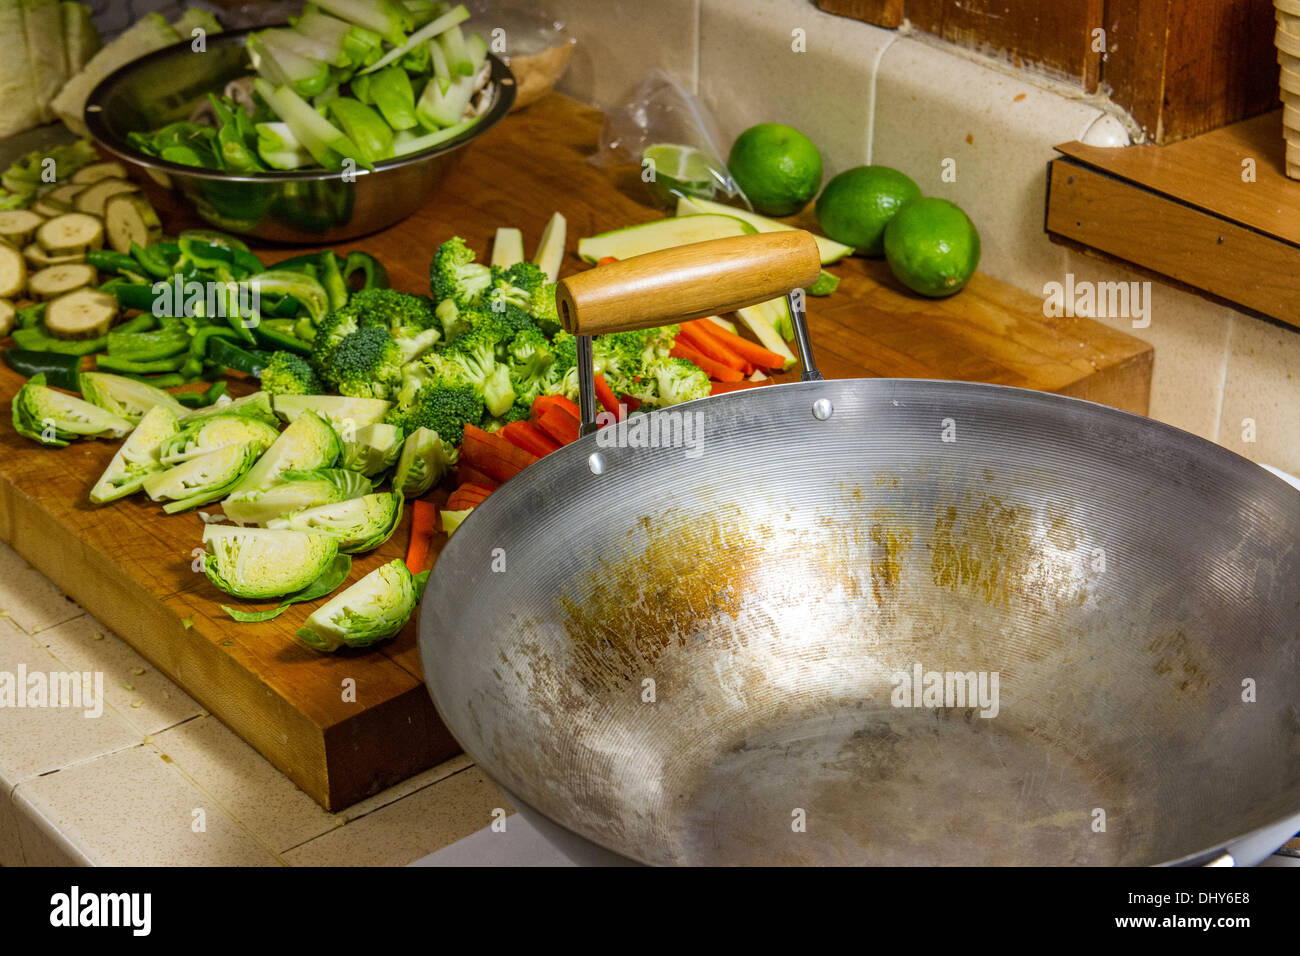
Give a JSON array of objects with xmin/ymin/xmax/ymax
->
[{"xmin": 818, "ymin": 0, "xmax": 1278, "ymax": 143}]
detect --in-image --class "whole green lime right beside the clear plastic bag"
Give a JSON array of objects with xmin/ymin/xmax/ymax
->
[{"xmin": 727, "ymin": 122, "xmax": 822, "ymax": 216}]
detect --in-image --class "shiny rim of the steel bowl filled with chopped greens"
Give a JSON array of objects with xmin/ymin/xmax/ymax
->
[{"xmin": 82, "ymin": 22, "xmax": 519, "ymax": 183}]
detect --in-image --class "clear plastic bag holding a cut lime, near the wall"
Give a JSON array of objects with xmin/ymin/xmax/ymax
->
[{"xmin": 590, "ymin": 69, "xmax": 751, "ymax": 209}]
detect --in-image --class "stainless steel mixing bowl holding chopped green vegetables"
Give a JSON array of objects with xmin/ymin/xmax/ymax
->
[{"xmin": 78, "ymin": 30, "xmax": 515, "ymax": 245}]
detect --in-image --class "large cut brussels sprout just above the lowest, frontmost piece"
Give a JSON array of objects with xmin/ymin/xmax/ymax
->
[{"xmin": 203, "ymin": 522, "xmax": 338, "ymax": 598}]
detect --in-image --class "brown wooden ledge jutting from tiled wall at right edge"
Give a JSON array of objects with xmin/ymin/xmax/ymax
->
[{"xmin": 1047, "ymin": 111, "xmax": 1300, "ymax": 326}]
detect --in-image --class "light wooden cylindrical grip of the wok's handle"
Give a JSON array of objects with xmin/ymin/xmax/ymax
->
[{"xmin": 555, "ymin": 229, "xmax": 822, "ymax": 336}]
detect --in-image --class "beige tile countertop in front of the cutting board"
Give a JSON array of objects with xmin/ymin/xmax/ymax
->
[{"xmin": 0, "ymin": 542, "xmax": 512, "ymax": 866}]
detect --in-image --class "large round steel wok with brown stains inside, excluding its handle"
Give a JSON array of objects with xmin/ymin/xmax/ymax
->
[{"xmin": 421, "ymin": 382, "xmax": 1300, "ymax": 864}]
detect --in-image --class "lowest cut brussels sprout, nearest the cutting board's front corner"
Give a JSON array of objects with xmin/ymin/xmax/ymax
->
[{"xmin": 295, "ymin": 556, "xmax": 420, "ymax": 650}]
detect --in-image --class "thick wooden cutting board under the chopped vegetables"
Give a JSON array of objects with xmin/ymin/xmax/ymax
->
[{"xmin": 0, "ymin": 95, "xmax": 1152, "ymax": 810}]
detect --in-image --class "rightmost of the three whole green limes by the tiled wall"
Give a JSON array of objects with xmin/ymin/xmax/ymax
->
[{"xmin": 885, "ymin": 196, "xmax": 979, "ymax": 299}]
